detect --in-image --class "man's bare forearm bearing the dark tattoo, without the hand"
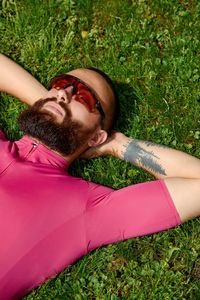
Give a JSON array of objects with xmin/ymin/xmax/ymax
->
[{"xmin": 114, "ymin": 136, "xmax": 200, "ymax": 179}]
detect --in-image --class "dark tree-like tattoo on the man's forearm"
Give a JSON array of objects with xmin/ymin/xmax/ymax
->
[{"xmin": 122, "ymin": 139, "xmax": 168, "ymax": 175}]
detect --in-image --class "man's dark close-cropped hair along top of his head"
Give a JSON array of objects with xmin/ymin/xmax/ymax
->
[{"xmin": 87, "ymin": 67, "xmax": 120, "ymax": 133}]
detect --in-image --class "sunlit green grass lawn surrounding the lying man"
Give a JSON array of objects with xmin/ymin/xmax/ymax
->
[{"xmin": 0, "ymin": 0, "xmax": 200, "ymax": 300}]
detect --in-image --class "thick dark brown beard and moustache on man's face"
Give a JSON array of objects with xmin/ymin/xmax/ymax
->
[{"xmin": 18, "ymin": 98, "xmax": 96, "ymax": 155}]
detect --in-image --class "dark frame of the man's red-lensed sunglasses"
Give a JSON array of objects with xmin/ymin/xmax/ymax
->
[{"xmin": 47, "ymin": 74, "xmax": 105, "ymax": 129}]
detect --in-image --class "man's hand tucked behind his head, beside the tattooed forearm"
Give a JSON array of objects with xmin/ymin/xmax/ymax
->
[{"xmin": 80, "ymin": 131, "xmax": 127, "ymax": 158}]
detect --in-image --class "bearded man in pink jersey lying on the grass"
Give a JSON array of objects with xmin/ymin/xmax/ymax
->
[{"xmin": 0, "ymin": 55, "xmax": 200, "ymax": 299}]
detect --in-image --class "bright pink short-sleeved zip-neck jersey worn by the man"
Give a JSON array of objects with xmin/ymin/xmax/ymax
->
[{"xmin": 0, "ymin": 131, "xmax": 180, "ymax": 300}]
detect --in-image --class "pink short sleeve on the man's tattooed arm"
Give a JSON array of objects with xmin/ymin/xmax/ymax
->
[{"xmin": 86, "ymin": 180, "xmax": 180, "ymax": 251}]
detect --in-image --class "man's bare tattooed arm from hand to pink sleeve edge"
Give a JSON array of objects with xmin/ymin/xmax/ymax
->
[{"xmin": 82, "ymin": 132, "xmax": 200, "ymax": 222}]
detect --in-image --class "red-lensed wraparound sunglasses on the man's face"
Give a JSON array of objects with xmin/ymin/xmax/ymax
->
[{"xmin": 47, "ymin": 74, "xmax": 105, "ymax": 129}]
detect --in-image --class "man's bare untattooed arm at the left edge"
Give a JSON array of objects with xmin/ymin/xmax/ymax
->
[{"xmin": 0, "ymin": 54, "xmax": 47, "ymax": 106}]
